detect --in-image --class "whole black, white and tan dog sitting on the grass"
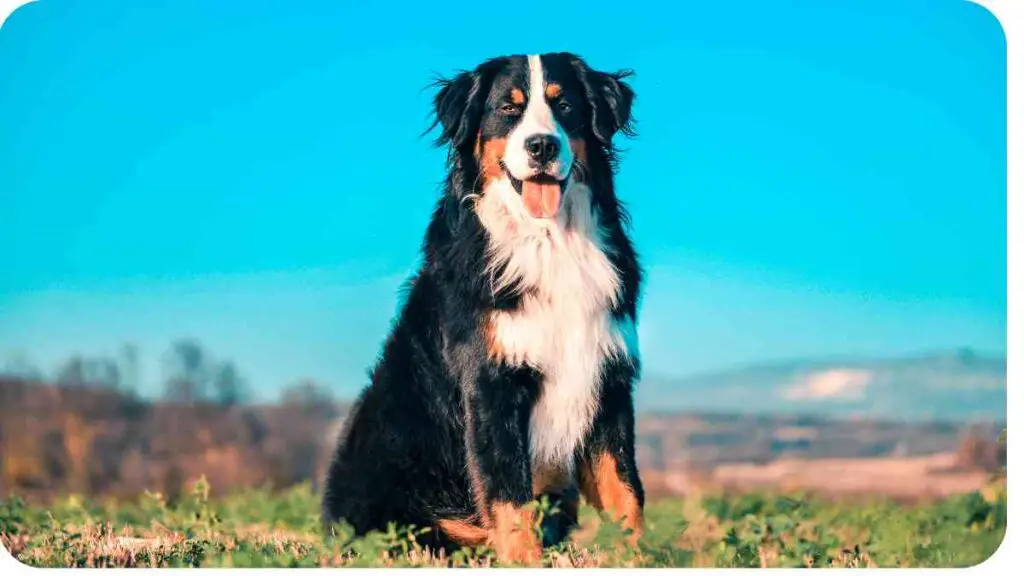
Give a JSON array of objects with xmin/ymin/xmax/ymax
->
[{"xmin": 322, "ymin": 52, "xmax": 644, "ymax": 563}]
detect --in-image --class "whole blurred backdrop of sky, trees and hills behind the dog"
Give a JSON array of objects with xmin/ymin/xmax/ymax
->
[{"xmin": 0, "ymin": 0, "xmax": 1007, "ymax": 500}]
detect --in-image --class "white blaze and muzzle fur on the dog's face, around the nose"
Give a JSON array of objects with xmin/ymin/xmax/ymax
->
[{"xmin": 502, "ymin": 54, "xmax": 573, "ymax": 180}]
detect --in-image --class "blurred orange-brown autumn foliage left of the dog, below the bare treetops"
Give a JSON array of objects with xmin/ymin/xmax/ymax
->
[{"xmin": 0, "ymin": 379, "xmax": 341, "ymax": 499}]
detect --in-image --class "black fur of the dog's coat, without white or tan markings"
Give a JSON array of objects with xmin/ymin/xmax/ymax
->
[{"xmin": 323, "ymin": 53, "xmax": 643, "ymax": 548}]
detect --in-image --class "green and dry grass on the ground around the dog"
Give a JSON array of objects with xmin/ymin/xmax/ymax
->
[{"xmin": 0, "ymin": 473, "xmax": 1007, "ymax": 567}]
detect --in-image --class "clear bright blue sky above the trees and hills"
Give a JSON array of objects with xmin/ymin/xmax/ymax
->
[{"xmin": 0, "ymin": 0, "xmax": 1007, "ymax": 397}]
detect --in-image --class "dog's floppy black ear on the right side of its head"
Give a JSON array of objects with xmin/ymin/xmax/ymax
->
[{"xmin": 571, "ymin": 57, "xmax": 636, "ymax": 147}]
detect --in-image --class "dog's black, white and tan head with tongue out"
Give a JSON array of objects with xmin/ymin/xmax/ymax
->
[{"xmin": 423, "ymin": 52, "xmax": 633, "ymax": 218}]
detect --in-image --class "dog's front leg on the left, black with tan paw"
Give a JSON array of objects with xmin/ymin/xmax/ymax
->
[{"xmin": 463, "ymin": 364, "xmax": 541, "ymax": 563}]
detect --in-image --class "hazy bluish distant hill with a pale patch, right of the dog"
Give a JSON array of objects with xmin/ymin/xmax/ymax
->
[{"xmin": 637, "ymin": 344, "xmax": 1007, "ymax": 422}]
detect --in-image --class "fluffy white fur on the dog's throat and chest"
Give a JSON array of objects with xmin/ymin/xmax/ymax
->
[{"xmin": 476, "ymin": 180, "xmax": 637, "ymax": 469}]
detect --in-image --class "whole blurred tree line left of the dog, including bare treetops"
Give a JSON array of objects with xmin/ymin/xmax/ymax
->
[{"xmin": 0, "ymin": 339, "xmax": 344, "ymax": 499}]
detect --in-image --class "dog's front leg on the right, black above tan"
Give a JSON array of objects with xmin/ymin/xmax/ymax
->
[{"xmin": 577, "ymin": 360, "xmax": 644, "ymax": 545}]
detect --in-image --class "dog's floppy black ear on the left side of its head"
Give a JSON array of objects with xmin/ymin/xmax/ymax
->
[{"xmin": 424, "ymin": 70, "xmax": 486, "ymax": 148}]
